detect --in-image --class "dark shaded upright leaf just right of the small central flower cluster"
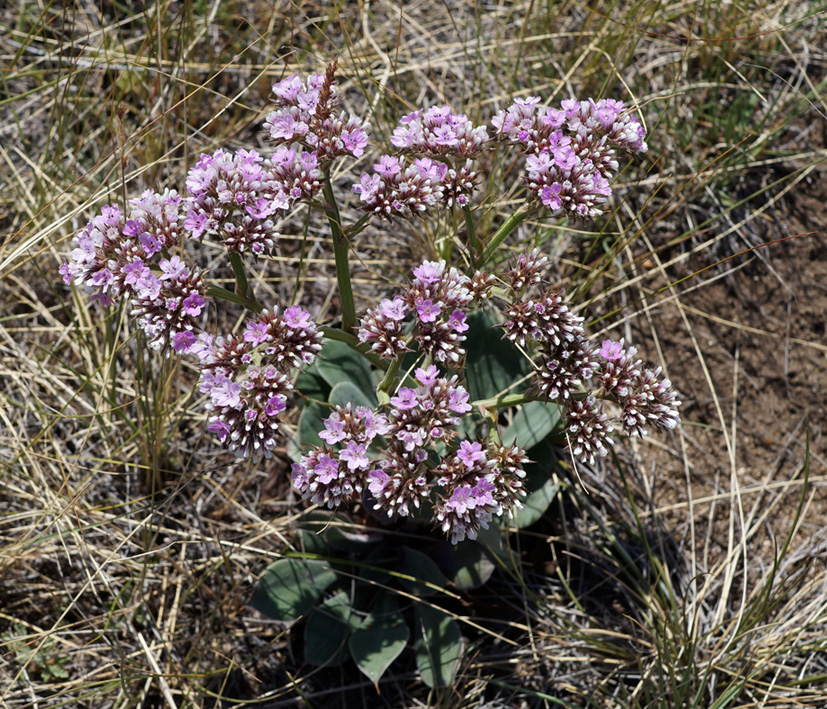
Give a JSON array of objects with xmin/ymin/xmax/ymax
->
[{"xmin": 465, "ymin": 311, "xmax": 530, "ymax": 401}]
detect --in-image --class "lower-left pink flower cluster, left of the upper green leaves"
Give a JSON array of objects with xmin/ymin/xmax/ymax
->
[{"xmin": 196, "ymin": 305, "xmax": 322, "ymax": 458}]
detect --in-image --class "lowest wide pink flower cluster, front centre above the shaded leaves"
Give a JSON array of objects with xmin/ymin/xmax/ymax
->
[{"xmin": 293, "ymin": 365, "xmax": 526, "ymax": 544}]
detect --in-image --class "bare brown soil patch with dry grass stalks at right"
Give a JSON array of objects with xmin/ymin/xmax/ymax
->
[{"xmin": 635, "ymin": 173, "xmax": 827, "ymax": 561}]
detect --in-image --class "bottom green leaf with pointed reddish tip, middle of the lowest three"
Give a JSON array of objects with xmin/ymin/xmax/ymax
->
[{"xmin": 348, "ymin": 593, "xmax": 411, "ymax": 684}]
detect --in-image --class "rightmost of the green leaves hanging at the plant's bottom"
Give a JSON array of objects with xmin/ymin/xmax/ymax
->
[{"xmin": 414, "ymin": 603, "xmax": 463, "ymax": 687}]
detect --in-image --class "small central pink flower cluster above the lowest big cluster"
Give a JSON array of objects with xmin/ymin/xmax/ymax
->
[{"xmin": 357, "ymin": 261, "xmax": 492, "ymax": 369}]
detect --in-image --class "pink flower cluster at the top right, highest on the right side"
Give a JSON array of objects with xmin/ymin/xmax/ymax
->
[{"xmin": 491, "ymin": 96, "xmax": 647, "ymax": 217}]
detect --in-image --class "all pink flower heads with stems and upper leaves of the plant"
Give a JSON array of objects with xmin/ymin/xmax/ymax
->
[{"xmin": 60, "ymin": 64, "xmax": 680, "ymax": 683}]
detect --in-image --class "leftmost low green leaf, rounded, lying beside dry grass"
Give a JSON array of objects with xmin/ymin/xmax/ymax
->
[{"xmin": 250, "ymin": 559, "xmax": 336, "ymax": 621}]
